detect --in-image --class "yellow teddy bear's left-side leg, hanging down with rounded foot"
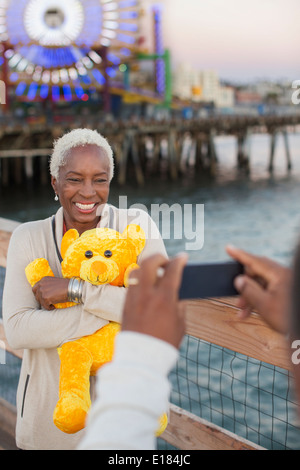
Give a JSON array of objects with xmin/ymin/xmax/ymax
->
[{"xmin": 53, "ymin": 341, "xmax": 93, "ymax": 434}]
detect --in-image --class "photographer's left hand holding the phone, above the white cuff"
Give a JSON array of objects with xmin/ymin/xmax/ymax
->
[{"xmin": 122, "ymin": 255, "xmax": 187, "ymax": 348}]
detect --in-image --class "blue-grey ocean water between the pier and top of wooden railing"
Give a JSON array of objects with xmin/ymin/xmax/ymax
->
[{"xmin": 0, "ymin": 131, "xmax": 300, "ymax": 263}]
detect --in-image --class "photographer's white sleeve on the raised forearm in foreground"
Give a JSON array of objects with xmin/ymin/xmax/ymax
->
[{"xmin": 79, "ymin": 332, "xmax": 178, "ymax": 450}]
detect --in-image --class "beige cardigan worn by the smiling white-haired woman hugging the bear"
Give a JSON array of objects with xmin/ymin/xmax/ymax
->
[{"xmin": 3, "ymin": 205, "xmax": 166, "ymax": 450}]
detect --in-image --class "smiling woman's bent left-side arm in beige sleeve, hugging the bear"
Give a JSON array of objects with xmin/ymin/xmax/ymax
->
[{"xmin": 3, "ymin": 226, "xmax": 106, "ymax": 349}]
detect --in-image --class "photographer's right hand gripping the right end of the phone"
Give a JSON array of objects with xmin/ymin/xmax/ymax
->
[{"xmin": 227, "ymin": 246, "xmax": 292, "ymax": 334}]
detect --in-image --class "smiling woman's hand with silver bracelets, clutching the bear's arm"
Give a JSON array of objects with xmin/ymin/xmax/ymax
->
[{"xmin": 32, "ymin": 277, "xmax": 69, "ymax": 310}]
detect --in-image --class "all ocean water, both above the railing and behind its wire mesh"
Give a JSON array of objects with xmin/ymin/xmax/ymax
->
[{"xmin": 0, "ymin": 132, "xmax": 300, "ymax": 449}]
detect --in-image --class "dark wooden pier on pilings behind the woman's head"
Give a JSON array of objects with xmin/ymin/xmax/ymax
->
[{"xmin": 0, "ymin": 114, "xmax": 300, "ymax": 186}]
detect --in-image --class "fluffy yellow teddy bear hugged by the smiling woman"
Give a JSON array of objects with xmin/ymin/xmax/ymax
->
[{"xmin": 25, "ymin": 224, "xmax": 167, "ymax": 435}]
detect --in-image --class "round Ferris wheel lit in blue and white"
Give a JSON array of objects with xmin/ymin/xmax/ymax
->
[{"xmin": 0, "ymin": 0, "xmax": 140, "ymax": 100}]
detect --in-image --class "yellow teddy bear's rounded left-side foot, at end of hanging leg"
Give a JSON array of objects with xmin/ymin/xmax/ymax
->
[{"xmin": 53, "ymin": 390, "xmax": 91, "ymax": 434}]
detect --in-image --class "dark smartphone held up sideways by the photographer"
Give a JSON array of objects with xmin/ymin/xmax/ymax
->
[{"xmin": 179, "ymin": 261, "xmax": 244, "ymax": 300}]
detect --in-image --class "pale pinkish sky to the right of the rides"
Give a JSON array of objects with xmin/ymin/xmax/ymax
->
[{"xmin": 160, "ymin": 0, "xmax": 300, "ymax": 81}]
